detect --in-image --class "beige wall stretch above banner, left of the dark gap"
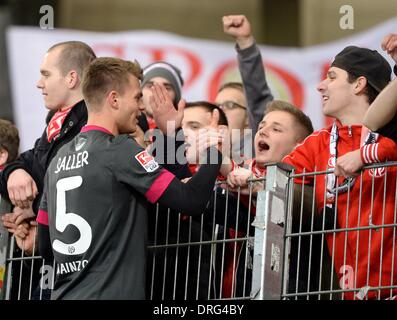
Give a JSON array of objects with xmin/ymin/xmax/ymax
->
[{"xmin": 59, "ymin": 0, "xmax": 263, "ymax": 40}]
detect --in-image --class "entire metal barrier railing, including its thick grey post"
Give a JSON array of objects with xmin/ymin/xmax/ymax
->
[{"xmin": 0, "ymin": 163, "xmax": 397, "ymax": 300}]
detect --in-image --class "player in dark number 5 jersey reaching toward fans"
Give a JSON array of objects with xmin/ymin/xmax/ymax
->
[{"xmin": 37, "ymin": 58, "xmax": 222, "ymax": 299}]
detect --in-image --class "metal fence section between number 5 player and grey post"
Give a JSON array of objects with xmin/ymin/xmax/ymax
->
[{"xmin": 147, "ymin": 182, "xmax": 253, "ymax": 299}]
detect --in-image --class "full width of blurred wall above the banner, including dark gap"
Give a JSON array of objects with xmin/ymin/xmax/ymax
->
[{"xmin": 56, "ymin": 0, "xmax": 397, "ymax": 46}]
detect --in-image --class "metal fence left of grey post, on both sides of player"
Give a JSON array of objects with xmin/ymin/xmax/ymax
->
[{"xmin": 0, "ymin": 184, "xmax": 253, "ymax": 300}]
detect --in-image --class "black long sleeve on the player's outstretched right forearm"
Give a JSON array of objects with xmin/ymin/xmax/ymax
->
[{"xmin": 158, "ymin": 148, "xmax": 222, "ymax": 215}]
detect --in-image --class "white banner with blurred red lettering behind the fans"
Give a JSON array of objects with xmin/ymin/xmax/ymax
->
[{"xmin": 7, "ymin": 18, "xmax": 397, "ymax": 151}]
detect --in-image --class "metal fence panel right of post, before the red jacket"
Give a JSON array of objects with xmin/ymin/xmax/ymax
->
[{"xmin": 254, "ymin": 162, "xmax": 397, "ymax": 300}]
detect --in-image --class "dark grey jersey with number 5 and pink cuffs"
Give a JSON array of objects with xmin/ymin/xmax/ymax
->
[{"xmin": 37, "ymin": 126, "xmax": 174, "ymax": 299}]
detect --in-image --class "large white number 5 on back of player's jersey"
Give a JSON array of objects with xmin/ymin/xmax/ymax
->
[{"xmin": 52, "ymin": 176, "xmax": 92, "ymax": 255}]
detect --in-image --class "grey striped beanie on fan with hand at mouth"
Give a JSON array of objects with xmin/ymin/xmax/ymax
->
[{"xmin": 142, "ymin": 61, "xmax": 183, "ymax": 106}]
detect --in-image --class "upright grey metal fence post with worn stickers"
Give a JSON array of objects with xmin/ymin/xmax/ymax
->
[{"xmin": 251, "ymin": 164, "xmax": 291, "ymax": 300}]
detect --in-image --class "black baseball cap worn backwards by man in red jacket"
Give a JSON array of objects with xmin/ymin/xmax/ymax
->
[{"xmin": 331, "ymin": 46, "xmax": 391, "ymax": 92}]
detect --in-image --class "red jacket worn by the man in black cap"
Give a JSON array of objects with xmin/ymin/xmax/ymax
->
[{"xmin": 283, "ymin": 123, "xmax": 397, "ymax": 299}]
